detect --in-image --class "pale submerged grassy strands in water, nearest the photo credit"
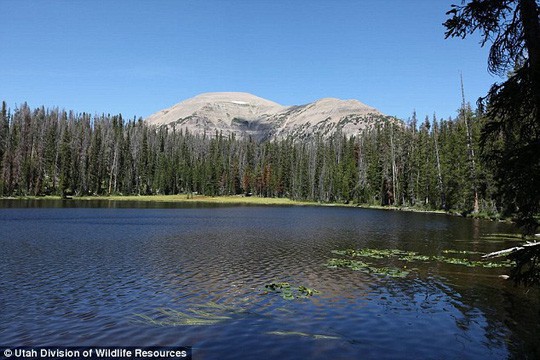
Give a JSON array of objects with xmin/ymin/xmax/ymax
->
[{"xmin": 134, "ymin": 302, "xmax": 243, "ymax": 326}]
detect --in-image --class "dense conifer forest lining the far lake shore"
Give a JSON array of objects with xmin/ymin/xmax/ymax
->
[{"xmin": 0, "ymin": 102, "xmax": 504, "ymax": 214}]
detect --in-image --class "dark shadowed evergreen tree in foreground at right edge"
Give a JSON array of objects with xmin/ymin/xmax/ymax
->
[{"xmin": 444, "ymin": 0, "xmax": 540, "ymax": 234}]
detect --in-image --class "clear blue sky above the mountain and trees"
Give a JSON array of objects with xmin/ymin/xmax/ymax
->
[{"xmin": 0, "ymin": 0, "xmax": 501, "ymax": 119}]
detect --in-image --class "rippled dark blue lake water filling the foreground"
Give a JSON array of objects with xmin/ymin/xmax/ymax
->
[{"xmin": 0, "ymin": 201, "xmax": 540, "ymax": 359}]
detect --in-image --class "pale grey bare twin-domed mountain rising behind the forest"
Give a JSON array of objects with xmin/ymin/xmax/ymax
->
[{"xmin": 146, "ymin": 92, "xmax": 389, "ymax": 140}]
